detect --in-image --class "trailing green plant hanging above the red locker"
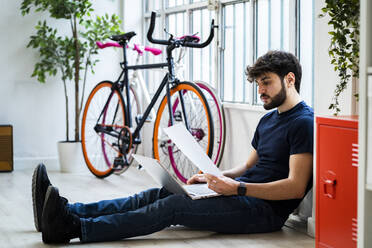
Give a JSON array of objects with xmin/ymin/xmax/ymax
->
[{"xmin": 319, "ymin": 0, "xmax": 360, "ymax": 115}]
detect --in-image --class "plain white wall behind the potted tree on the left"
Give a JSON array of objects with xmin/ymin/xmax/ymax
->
[{"xmin": 0, "ymin": 0, "xmax": 122, "ymax": 169}]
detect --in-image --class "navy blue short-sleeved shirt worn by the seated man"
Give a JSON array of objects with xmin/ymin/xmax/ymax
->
[{"xmin": 236, "ymin": 101, "xmax": 314, "ymax": 216}]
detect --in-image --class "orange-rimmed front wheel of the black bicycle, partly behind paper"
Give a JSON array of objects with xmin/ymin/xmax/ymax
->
[{"xmin": 153, "ymin": 82, "xmax": 214, "ymax": 183}]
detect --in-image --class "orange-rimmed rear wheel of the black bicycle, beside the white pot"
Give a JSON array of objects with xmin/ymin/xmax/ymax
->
[{"xmin": 81, "ymin": 81, "xmax": 125, "ymax": 178}]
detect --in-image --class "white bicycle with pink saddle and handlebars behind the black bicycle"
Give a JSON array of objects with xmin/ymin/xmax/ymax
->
[{"xmin": 96, "ymin": 39, "xmax": 226, "ymax": 182}]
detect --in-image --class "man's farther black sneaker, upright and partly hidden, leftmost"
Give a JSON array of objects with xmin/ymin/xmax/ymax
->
[{"xmin": 32, "ymin": 164, "xmax": 51, "ymax": 232}]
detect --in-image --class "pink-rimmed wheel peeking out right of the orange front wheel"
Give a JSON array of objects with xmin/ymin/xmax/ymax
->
[{"xmin": 194, "ymin": 81, "xmax": 226, "ymax": 167}]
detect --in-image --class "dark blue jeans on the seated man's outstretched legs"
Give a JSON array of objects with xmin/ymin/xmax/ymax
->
[{"xmin": 68, "ymin": 188, "xmax": 286, "ymax": 242}]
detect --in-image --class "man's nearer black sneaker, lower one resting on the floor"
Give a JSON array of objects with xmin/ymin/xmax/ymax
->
[{"xmin": 42, "ymin": 186, "xmax": 81, "ymax": 244}]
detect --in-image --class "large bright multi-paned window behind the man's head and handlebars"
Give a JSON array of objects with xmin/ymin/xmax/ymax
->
[{"xmin": 145, "ymin": 0, "xmax": 313, "ymax": 105}]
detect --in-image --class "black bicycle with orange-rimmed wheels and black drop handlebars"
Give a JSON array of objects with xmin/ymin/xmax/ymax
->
[{"xmin": 82, "ymin": 13, "xmax": 215, "ymax": 178}]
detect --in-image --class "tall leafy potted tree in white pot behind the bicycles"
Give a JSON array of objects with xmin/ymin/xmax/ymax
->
[{"xmin": 20, "ymin": 0, "xmax": 121, "ymax": 168}]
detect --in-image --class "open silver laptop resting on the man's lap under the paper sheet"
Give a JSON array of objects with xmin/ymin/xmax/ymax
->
[{"xmin": 132, "ymin": 154, "xmax": 220, "ymax": 200}]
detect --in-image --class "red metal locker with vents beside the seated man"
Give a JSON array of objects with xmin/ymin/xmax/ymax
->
[{"xmin": 315, "ymin": 116, "xmax": 358, "ymax": 248}]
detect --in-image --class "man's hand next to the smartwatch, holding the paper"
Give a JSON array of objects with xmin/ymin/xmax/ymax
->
[{"xmin": 204, "ymin": 174, "xmax": 240, "ymax": 195}]
